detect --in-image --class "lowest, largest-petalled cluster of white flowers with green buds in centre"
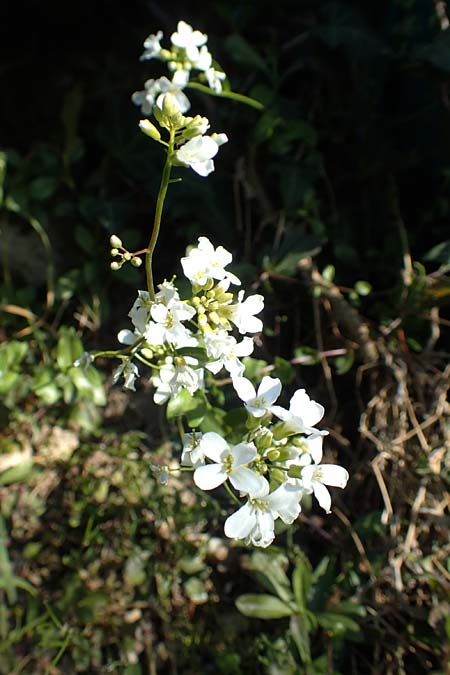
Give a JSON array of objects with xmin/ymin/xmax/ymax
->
[{"xmin": 181, "ymin": 376, "xmax": 348, "ymax": 547}]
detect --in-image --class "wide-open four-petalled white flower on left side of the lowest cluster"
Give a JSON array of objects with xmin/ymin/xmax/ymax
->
[{"xmin": 194, "ymin": 431, "xmax": 269, "ymax": 494}]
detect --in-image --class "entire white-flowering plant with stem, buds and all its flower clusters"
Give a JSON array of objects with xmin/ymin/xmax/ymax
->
[{"xmin": 104, "ymin": 21, "xmax": 348, "ymax": 547}]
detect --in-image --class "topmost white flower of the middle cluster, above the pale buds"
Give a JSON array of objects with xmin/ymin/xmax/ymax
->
[{"xmin": 181, "ymin": 237, "xmax": 241, "ymax": 290}]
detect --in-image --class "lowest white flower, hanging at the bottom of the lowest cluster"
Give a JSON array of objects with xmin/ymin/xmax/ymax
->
[{"xmin": 224, "ymin": 485, "xmax": 301, "ymax": 548}]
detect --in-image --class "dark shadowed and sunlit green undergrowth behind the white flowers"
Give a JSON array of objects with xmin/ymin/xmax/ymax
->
[{"xmin": 0, "ymin": 0, "xmax": 450, "ymax": 675}]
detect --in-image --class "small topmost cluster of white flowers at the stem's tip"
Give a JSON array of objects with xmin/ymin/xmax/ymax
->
[{"xmin": 132, "ymin": 21, "xmax": 226, "ymax": 115}]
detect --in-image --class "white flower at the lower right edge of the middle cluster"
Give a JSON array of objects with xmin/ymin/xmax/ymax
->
[{"xmin": 204, "ymin": 330, "xmax": 255, "ymax": 380}]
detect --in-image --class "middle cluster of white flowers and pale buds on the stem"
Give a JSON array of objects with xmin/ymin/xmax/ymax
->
[{"xmin": 115, "ymin": 237, "xmax": 264, "ymax": 405}]
